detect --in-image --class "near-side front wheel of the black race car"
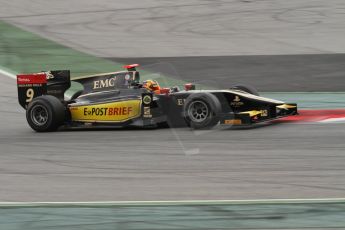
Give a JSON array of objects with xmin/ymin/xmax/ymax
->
[{"xmin": 183, "ymin": 93, "xmax": 221, "ymax": 129}]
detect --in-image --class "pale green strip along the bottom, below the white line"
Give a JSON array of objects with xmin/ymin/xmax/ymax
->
[{"xmin": 0, "ymin": 199, "xmax": 345, "ymax": 230}]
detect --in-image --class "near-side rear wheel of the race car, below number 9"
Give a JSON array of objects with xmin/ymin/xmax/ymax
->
[{"xmin": 26, "ymin": 95, "xmax": 65, "ymax": 132}]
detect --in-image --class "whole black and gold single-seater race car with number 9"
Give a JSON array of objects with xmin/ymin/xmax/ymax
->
[{"xmin": 17, "ymin": 64, "xmax": 297, "ymax": 132}]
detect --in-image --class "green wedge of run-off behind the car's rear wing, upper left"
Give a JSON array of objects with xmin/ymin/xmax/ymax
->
[{"xmin": 0, "ymin": 21, "xmax": 121, "ymax": 76}]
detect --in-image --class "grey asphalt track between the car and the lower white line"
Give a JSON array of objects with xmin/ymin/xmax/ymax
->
[{"xmin": 0, "ymin": 73, "xmax": 345, "ymax": 201}]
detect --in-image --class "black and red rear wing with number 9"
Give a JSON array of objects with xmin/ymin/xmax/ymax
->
[{"xmin": 17, "ymin": 70, "xmax": 71, "ymax": 109}]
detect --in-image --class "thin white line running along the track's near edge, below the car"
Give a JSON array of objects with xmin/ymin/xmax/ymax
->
[{"xmin": 0, "ymin": 198, "xmax": 345, "ymax": 208}]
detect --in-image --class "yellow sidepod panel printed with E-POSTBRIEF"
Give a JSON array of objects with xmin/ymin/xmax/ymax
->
[{"xmin": 69, "ymin": 100, "xmax": 141, "ymax": 122}]
